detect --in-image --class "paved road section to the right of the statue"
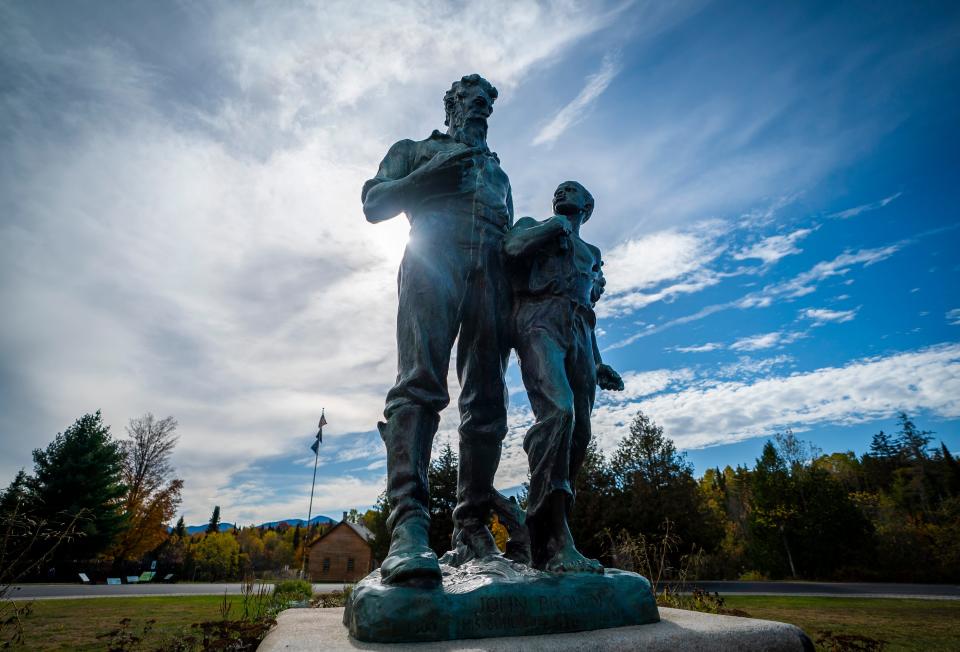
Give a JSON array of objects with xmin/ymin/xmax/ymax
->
[{"xmin": 691, "ymin": 581, "xmax": 960, "ymax": 600}]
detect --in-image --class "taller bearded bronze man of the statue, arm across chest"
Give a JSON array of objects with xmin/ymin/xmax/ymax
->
[{"xmin": 361, "ymin": 75, "xmax": 513, "ymax": 586}]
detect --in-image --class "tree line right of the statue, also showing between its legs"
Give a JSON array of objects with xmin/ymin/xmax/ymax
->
[{"xmin": 368, "ymin": 412, "xmax": 960, "ymax": 582}]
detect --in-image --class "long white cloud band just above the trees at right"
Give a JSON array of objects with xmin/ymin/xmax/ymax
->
[{"xmin": 594, "ymin": 344, "xmax": 960, "ymax": 449}]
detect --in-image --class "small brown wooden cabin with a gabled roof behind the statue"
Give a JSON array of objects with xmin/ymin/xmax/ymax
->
[{"xmin": 307, "ymin": 514, "xmax": 379, "ymax": 582}]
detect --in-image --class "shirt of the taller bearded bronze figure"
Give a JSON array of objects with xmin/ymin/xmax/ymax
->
[{"xmin": 364, "ymin": 131, "xmax": 513, "ymax": 231}]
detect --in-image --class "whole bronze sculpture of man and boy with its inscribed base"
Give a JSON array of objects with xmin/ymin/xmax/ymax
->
[{"xmin": 344, "ymin": 75, "xmax": 659, "ymax": 643}]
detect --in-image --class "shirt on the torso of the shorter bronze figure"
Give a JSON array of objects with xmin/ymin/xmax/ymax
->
[{"xmin": 510, "ymin": 217, "xmax": 603, "ymax": 312}]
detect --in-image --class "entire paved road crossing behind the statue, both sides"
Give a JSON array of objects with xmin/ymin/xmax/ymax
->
[{"xmin": 11, "ymin": 581, "xmax": 960, "ymax": 600}]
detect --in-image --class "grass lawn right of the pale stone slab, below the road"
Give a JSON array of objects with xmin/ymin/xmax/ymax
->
[{"xmin": 723, "ymin": 595, "xmax": 960, "ymax": 650}]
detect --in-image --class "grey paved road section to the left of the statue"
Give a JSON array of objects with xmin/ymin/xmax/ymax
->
[{"xmin": 9, "ymin": 583, "xmax": 344, "ymax": 600}]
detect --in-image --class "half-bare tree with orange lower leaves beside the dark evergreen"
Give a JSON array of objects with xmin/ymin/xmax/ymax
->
[{"xmin": 114, "ymin": 413, "xmax": 183, "ymax": 560}]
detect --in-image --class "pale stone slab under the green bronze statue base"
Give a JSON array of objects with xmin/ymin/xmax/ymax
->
[{"xmin": 259, "ymin": 607, "xmax": 813, "ymax": 652}]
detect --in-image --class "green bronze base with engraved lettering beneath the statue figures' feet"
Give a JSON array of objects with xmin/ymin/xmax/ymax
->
[{"xmin": 344, "ymin": 557, "xmax": 660, "ymax": 643}]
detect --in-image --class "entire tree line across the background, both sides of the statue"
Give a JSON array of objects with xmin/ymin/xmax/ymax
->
[{"xmin": 0, "ymin": 412, "xmax": 960, "ymax": 582}]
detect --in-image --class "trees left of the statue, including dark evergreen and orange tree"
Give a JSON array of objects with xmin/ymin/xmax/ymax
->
[{"xmin": 0, "ymin": 412, "xmax": 340, "ymax": 584}]
